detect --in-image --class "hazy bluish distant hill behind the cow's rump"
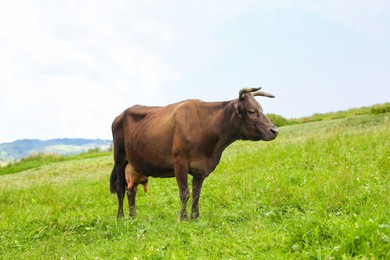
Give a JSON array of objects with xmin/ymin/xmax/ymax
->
[{"xmin": 0, "ymin": 138, "xmax": 112, "ymax": 164}]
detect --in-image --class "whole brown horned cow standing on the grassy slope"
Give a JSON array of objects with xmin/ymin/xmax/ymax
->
[{"xmin": 110, "ymin": 88, "xmax": 278, "ymax": 220}]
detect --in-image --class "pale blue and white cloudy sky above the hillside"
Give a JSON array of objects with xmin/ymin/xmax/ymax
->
[{"xmin": 0, "ymin": 0, "xmax": 390, "ymax": 143}]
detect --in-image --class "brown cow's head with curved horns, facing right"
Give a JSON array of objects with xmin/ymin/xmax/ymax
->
[{"xmin": 236, "ymin": 88, "xmax": 278, "ymax": 141}]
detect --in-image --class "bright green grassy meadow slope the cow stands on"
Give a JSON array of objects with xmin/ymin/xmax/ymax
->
[{"xmin": 0, "ymin": 107, "xmax": 390, "ymax": 259}]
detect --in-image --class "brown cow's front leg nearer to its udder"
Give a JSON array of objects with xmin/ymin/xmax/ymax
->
[{"xmin": 174, "ymin": 161, "xmax": 190, "ymax": 220}]
